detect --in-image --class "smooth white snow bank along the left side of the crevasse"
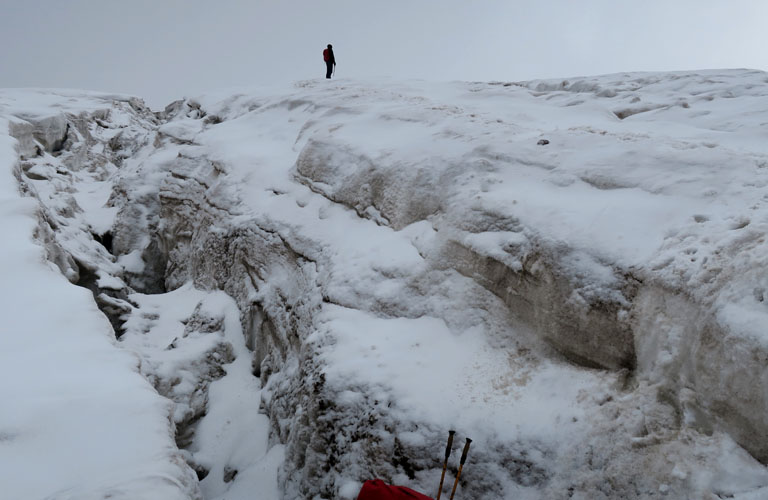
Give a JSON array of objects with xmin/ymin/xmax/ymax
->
[{"xmin": 0, "ymin": 95, "xmax": 198, "ymax": 500}]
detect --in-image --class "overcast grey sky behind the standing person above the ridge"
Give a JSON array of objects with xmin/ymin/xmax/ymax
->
[{"xmin": 0, "ymin": 0, "xmax": 768, "ymax": 108}]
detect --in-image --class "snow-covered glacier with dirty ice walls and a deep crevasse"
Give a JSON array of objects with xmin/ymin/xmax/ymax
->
[{"xmin": 0, "ymin": 70, "xmax": 768, "ymax": 500}]
